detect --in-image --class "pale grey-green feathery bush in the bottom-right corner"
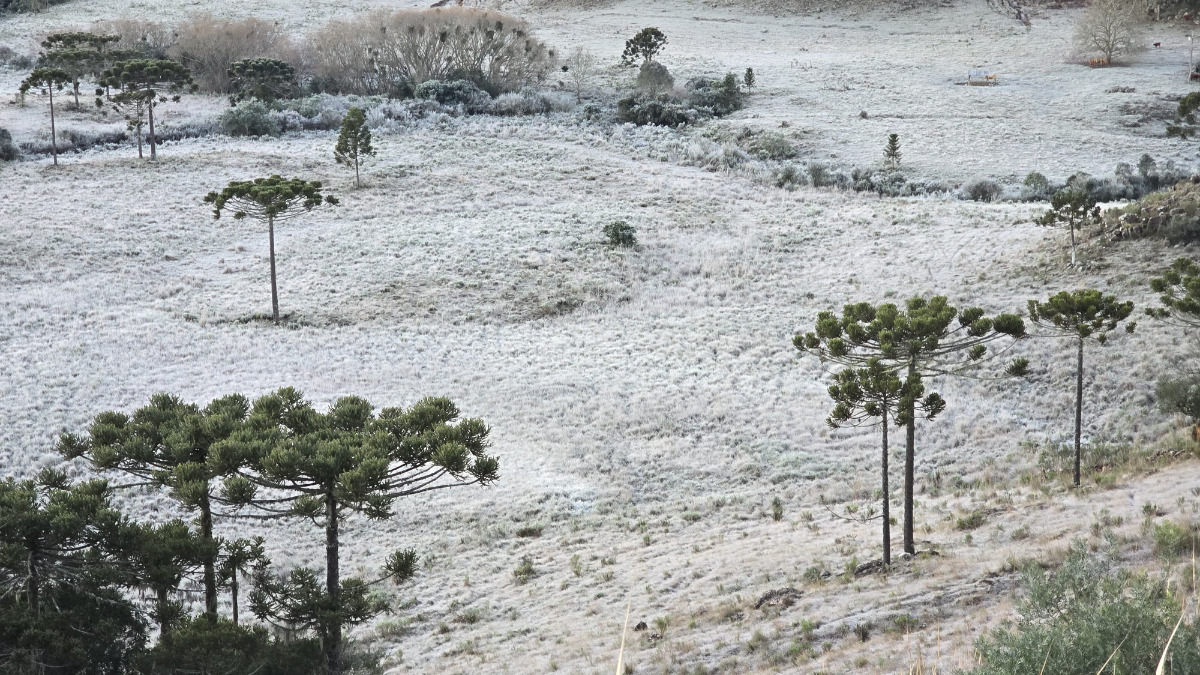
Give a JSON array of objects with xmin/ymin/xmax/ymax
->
[{"xmin": 971, "ymin": 540, "xmax": 1200, "ymax": 675}]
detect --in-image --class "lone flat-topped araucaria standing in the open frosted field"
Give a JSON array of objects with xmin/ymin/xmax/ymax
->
[{"xmin": 204, "ymin": 175, "xmax": 337, "ymax": 323}]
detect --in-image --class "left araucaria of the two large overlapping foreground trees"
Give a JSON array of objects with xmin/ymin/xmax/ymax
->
[{"xmin": 59, "ymin": 394, "xmax": 250, "ymax": 621}]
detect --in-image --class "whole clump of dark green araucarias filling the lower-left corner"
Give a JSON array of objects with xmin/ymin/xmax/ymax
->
[{"xmin": 0, "ymin": 388, "xmax": 499, "ymax": 675}]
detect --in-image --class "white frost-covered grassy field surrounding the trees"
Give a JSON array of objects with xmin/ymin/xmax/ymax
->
[{"xmin": 0, "ymin": 0, "xmax": 1198, "ymax": 673}]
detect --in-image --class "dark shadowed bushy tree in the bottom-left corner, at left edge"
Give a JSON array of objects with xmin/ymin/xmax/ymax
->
[{"xmin": 0, "ymin": 470, "xmax": 145, "ymax": 673}]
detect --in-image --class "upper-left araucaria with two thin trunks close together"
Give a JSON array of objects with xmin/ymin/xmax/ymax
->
[{"xmin": 100, "ymin": 59, "xmax": 197, "ymax": 160}]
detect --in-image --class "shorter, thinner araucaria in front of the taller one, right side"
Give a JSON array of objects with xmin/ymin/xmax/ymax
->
[{"xmin": 826, "ymin": 357, "xmax": 946, "ymax": 565}]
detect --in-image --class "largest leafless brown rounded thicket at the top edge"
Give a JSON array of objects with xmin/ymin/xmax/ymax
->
[{"xmin": 306, "ymin": 7, "xmax": 557, "ymax": 97}]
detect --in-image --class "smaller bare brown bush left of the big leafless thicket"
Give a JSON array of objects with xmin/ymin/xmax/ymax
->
[{"xmin": 167, "ymin": 14, "xmax": 286, "ymax": 94}]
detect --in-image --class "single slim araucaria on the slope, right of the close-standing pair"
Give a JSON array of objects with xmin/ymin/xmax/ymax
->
[{"xmin": 1030, "ymin": 288, "xmax": 1136, "ymax": 485}]
